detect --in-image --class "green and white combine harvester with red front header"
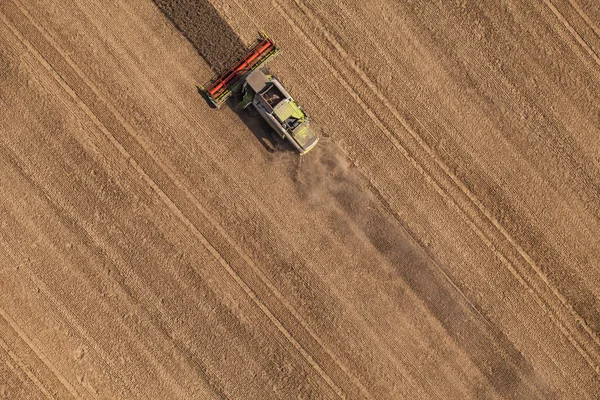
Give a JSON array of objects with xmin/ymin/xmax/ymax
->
[{"xmin": 203, "ymin": 34, "xmax": 319, "ymax": 155}]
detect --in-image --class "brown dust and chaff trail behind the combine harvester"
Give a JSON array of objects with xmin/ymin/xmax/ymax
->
[{"xmin": 290, "ymin": 138, "xmax": 553, "ymax": 398}]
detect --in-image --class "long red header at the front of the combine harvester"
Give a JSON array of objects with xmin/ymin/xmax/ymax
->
[{"xmin": 205, "ymin": 34, "xmax": 279, "ymax": 108}]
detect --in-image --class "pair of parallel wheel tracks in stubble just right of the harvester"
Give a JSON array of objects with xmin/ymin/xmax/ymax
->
[{"xmin": 273, "ymin": 0, "xmax": 600, "ymax": 374}]
